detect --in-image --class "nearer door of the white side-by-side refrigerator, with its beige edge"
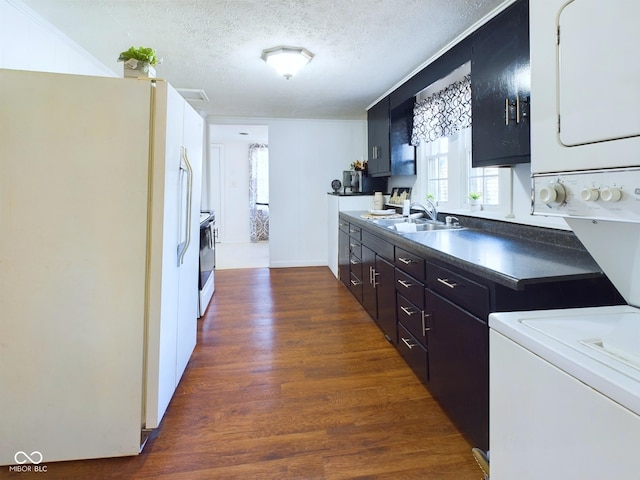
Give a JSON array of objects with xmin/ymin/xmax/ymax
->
[{"xmin": 144, "ymin": 82, "xmax": 183, "ymax": 428}]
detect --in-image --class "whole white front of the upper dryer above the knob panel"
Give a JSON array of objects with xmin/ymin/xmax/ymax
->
[{"xmin": 529, "ymin": 0, "xmax": 640, "ymax": 174}]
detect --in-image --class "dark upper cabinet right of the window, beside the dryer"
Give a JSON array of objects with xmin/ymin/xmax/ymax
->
[{"xmin": 471, "ymin": 0, "xmax": 531, "ymax": 167}]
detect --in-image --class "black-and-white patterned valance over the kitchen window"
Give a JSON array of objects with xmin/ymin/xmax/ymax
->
[{"xmin": 411, "ymin": 75, "xmax": 471, "ymax": 146}]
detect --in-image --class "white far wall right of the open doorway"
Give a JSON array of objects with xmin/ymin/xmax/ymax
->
[{"xmin": 207, "ymin": 117, "xmax": 367, "ymax": 267}]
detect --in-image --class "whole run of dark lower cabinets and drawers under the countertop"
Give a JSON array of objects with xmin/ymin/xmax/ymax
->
[{"xmin": 339, "ymin": 214, "xmax": 624, "ymax": 450}]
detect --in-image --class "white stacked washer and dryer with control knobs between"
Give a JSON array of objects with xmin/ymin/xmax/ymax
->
[{"xmin": 489, "ymin": 0, "xmax": 640, "ymax": 480}]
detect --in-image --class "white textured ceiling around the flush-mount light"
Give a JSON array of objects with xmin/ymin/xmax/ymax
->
[{"xmin": 23, "ymin": 0, "xmax": 511, "ymax": 118}]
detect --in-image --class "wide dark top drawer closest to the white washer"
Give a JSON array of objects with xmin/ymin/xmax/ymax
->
[{"xmin": 427, "ymin": 264, "xmax": 490, "ymax": 322}]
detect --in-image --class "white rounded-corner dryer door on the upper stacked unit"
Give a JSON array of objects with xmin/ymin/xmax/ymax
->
[{"xmin": 558, "ymin": 0, "xmax": 640, "ymax": 146}]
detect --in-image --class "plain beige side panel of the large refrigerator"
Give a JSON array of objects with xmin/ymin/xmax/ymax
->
[{"xmin": 0, "ymin": 70, "xmax": 150, "ymax": 465}]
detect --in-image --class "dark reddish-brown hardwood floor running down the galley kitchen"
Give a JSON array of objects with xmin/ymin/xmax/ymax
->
[{"xmin": 8, "ymin": 267, "xmax": 482, "ymax": 480}]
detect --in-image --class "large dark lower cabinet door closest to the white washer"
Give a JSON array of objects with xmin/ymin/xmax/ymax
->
[{"xmin": 425, "ymin": 289, "xmax": 489, "ymax": 450}]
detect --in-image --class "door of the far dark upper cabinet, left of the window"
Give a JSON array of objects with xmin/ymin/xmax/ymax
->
[{"xmin": 367, "ymin": 97, "xmax": 391, "ymax": 177}]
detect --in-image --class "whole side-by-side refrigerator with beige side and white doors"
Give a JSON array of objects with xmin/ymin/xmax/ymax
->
[{"xmin": 0, "ymin": 70, "xmax": 203, "ymax": 465}]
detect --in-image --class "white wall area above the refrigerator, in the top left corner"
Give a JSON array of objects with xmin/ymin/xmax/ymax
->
[{"xmin": 0, "ymin": 0, "xmax": 117, "ymax": 77}]
